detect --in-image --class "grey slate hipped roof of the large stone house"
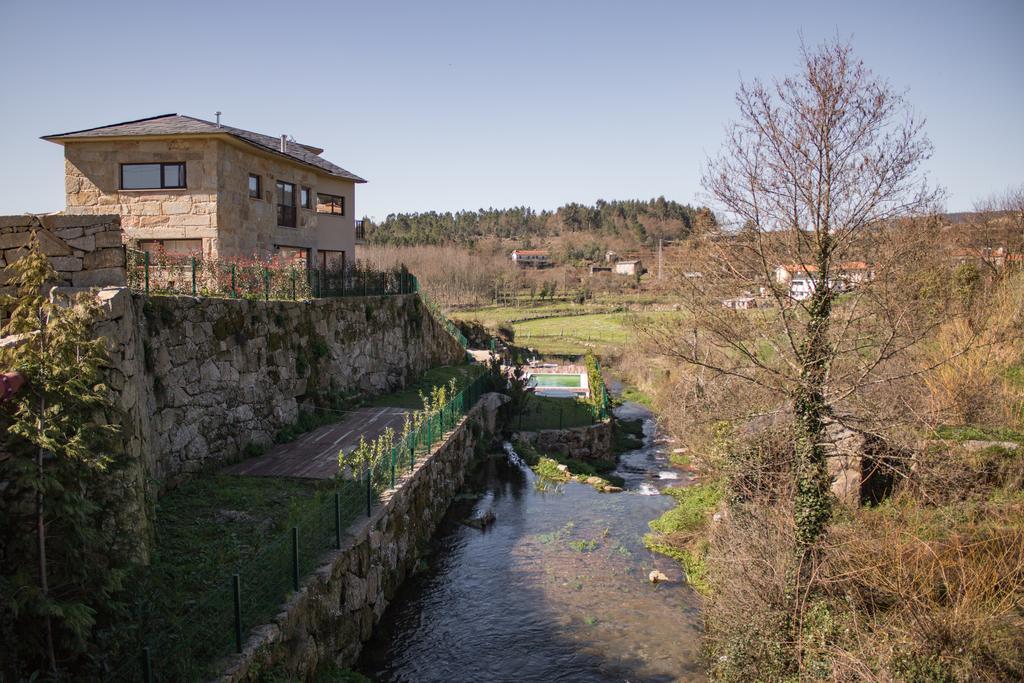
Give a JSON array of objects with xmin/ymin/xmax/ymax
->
[{"xmin": 43, "ymin": 114, "xmax": 366, "ymax": 182}]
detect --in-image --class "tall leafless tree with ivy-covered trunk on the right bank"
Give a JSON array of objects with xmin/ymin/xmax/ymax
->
[{"xmin": 645, "ymin": 41, "xmax": 941, "ymax": 555}]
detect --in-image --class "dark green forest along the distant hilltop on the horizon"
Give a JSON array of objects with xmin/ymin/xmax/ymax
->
[{"xmin": 365, "ymin": 197, "xmax": 715, "ymax": 247}]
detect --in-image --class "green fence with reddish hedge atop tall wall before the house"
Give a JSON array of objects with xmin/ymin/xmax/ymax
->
[{"xmin": 126, "ymin": 249, "xmax": 416, "ymax": 301}]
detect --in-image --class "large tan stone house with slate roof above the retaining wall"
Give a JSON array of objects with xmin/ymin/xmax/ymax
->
[{"xmin": 43, "ymin": 114, "xmax": 366, "ymax": 268}]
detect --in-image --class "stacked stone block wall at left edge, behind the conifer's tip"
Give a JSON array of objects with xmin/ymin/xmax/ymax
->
[{"xmin": 0, "ymin": 214, "xmax": 125, "ymax": 292}]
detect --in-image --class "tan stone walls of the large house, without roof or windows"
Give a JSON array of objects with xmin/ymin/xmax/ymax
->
[{"xmin": 65, "ymin": 136, "xmax": 355, "ymax": 265}]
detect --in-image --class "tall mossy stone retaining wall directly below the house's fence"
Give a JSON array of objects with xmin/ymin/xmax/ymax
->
[{"xmin": 97, "ymin": 290, "xmax": 465, "ymax": 487}]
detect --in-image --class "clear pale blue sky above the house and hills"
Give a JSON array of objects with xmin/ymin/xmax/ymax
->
[{"xmin": 0, "ymin": 0, "xmax": 1024, "ymax": 217}]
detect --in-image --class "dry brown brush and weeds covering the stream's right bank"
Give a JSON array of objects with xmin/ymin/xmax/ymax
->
[{"xmin": 609, "ymin": 266, "xmax": 1024, "ymax": 681}]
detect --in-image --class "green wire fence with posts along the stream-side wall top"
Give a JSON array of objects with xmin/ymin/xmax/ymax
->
[{"xmin": 104, "ymin": 375, "xmax": 487, "ymax": 683}]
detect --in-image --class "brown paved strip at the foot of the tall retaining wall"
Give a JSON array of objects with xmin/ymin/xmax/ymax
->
[{"xmin": 224, "ymin": 408, "xmax": 410, "ymax": 479}]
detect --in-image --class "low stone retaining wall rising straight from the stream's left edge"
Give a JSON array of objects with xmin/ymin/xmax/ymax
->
[{"xmin": 221, "ymin": 394, "xmax": 507, "ymax": 683}]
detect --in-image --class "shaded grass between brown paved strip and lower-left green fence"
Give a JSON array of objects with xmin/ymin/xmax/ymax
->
[{"xmin": 123, "ymin": 474, "xmax": 344, "ymax": 678}]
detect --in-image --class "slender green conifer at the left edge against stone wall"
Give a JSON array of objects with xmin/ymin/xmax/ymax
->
[{"xmin": 0, "ymin": 234, "xmax": 122, "ymax": 680}]
